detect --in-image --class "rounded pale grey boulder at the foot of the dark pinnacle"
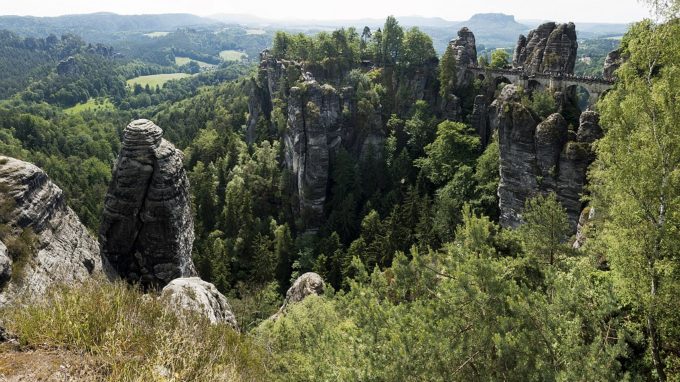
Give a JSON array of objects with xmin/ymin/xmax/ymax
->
[{"xmin": 161, "ymin": 277, "xmax": 238, "ymax": 330}]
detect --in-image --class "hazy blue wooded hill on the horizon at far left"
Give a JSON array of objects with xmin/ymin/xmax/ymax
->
[{"xmin": 0, "ymin": 13, "xmax": 217, "ymax": 42}]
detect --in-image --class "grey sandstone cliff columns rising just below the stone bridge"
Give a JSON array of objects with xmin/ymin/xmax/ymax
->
[{"xmin": 489, "ymin": 85, "xmax": 602, "ymax": 230}]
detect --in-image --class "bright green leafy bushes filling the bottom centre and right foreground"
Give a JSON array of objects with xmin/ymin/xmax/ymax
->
[{"xmin": 256, "ymin": 209, "xmax": 626, "ymax": 381}]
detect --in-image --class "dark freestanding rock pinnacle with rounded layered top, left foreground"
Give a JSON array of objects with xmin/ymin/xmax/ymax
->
[{"xmin": 99, "ymin": 119, "xmax": 196, "ymax": 287}]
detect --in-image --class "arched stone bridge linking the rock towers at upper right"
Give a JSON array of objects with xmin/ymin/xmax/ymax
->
[{"xmin": 468, "ymin": 66, "xmax": 614, "ymax": 105}]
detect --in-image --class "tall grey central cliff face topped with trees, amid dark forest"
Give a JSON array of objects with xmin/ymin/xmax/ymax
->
[{"xmin": 248, "ymin": 51, "xmax": 388, "ymax": 231}]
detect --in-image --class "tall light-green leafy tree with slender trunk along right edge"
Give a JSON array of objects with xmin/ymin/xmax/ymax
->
[{"xmin": 591, "ymin": 20, "xmax": 680, "ymax": 380}]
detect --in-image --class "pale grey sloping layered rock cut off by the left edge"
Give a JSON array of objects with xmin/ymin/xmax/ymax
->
[{"xmin": 0, "ymin": 156, "xmax": 113, "ymax": 307}]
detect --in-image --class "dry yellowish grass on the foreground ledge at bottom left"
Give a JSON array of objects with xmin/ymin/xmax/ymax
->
[{"xmin": 0, "ymin": 280, "xmax": 267, "ymax": 381}]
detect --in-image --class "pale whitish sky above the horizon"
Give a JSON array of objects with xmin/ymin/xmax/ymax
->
[{"xmin": 0, "ymin": 0, "xmax": 649, "ymax": 23}]
